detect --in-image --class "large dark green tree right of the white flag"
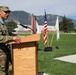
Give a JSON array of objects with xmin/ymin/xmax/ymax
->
[{"xmin": 59, "ymin": 16, "xmax": 74, "ymax": 32}]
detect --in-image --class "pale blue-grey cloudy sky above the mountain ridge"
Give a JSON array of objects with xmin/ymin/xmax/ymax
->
[{"xmin": 0, "ymin": 0, "xmax": 76, "ymax": 20}]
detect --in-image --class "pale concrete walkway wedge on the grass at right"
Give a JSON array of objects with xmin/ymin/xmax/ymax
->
[{"xmin": 54, "ymin": 54, "xmax": 76, "ymax": 63}]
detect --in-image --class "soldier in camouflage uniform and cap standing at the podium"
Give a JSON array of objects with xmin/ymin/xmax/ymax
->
[{"xmin": 0, "ymin": 6, "xmax": 20, "ymax": 75}]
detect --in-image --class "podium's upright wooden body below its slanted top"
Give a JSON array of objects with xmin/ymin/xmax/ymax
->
[{"xmin": 13, "ymin": 42, "xmax": 38, "ymax": 75}]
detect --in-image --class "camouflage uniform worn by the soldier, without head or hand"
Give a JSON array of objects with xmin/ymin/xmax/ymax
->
[{"xmin": 0, "ymin": 18, "xmax": 13, "ymax": 75}]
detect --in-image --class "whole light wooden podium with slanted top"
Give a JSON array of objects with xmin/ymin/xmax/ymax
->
[{"xmin": 9, "ymin": 34, "xmax": 40, "ymax": 75}]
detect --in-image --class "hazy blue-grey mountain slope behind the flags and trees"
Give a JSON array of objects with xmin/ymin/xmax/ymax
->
[{"xmin": 8, "ymin": 11, "xmax": 76, "ymax": 26}]
